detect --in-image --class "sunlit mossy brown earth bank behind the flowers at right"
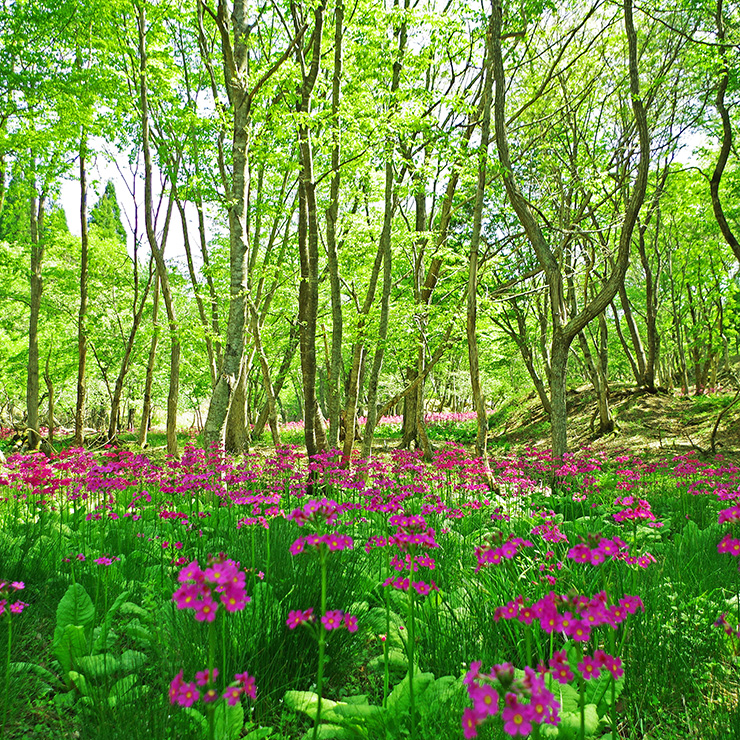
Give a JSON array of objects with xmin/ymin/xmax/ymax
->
[{"xmin": 489, "ymin": 386, "xmax": 740, "ymax": 459}]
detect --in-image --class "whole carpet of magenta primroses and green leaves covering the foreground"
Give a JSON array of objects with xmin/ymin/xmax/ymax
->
[{"xmin": 0, "ymin": 444, "xmax": 740, "ymax": 740}]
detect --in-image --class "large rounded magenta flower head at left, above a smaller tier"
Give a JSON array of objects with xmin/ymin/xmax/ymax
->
[{"xmin": 172, "ymin": 553, "xmax": 251, "ymax": 622}]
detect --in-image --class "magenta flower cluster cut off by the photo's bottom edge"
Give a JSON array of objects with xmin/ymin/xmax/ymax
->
[{"xmin": 462, "ymin": 661, "xmax": 560, "ymax": 738}]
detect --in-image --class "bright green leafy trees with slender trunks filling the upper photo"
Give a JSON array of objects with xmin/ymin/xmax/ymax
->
[{"xmin": 0, "ymin": 0, "xmax": 740, "ymax": 464}]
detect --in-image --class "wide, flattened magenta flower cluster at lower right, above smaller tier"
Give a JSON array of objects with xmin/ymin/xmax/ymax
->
[{"xmin": 493, "ymin": 591, "xmax": 644, "ymax": 642}]
